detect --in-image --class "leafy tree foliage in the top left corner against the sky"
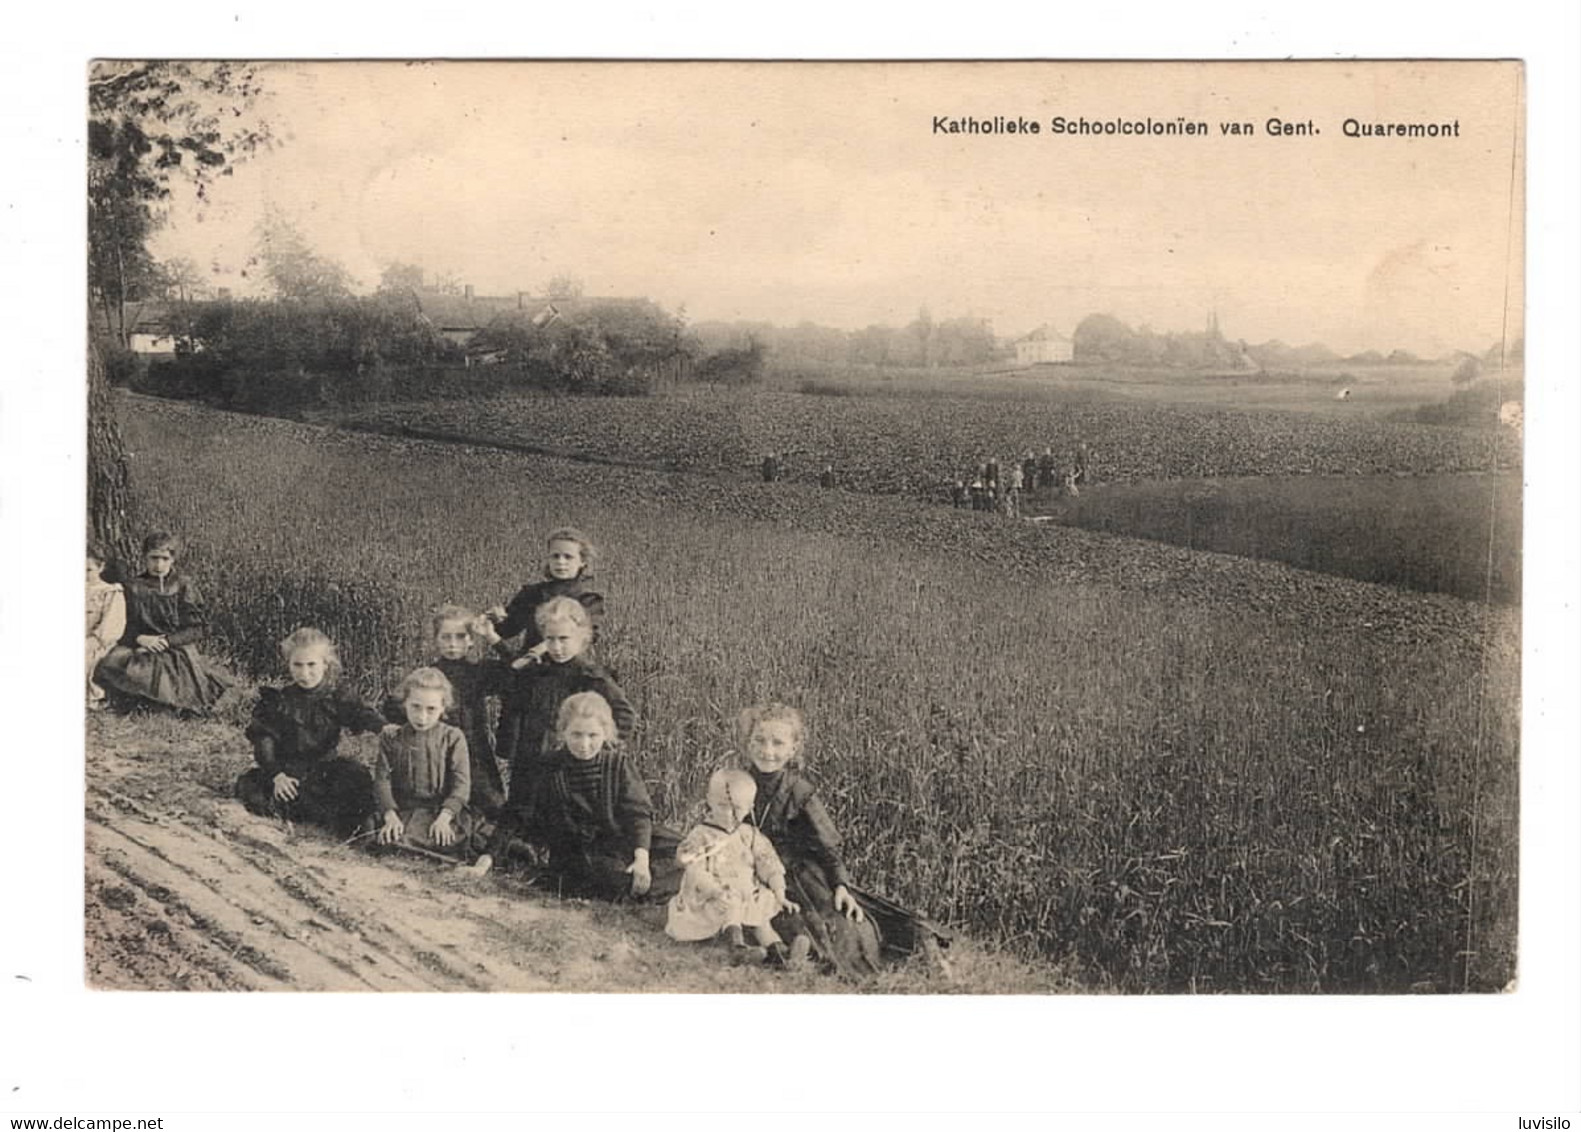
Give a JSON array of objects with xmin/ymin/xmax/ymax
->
[{"xmin": 87, "ymin": 62, "xmax": 270, "ymax": 345}]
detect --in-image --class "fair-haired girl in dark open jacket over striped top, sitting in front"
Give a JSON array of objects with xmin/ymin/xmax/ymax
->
[{"xmin": 471, "ymin": 692, "xmax": 678, "ymax": 900}]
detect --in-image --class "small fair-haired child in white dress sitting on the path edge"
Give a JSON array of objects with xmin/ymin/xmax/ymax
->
[{"xmin": 664, "ymin": 770, "xmax": 806, "ymax": 966}]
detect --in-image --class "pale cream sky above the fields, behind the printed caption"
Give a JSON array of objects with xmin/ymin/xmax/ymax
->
[{"xmin": 157, "ymin": 63, "xmax": 1524, "ymax": 356}]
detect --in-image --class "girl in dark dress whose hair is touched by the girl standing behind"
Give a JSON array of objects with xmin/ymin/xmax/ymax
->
[{"xmin": 384, "ymin": 606, "xmax": 511, "ymax": 817}]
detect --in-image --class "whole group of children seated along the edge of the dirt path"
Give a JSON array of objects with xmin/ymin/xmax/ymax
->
[{"xmin": 89, "ymin": 528, "xmax": 947, "ymax": 975}]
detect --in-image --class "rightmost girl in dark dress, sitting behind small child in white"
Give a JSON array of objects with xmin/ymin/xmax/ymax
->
[{"xmin": 737, "ymin": 704, "xmax": 949, "ymax": 977}]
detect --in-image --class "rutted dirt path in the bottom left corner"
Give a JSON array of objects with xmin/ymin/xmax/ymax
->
[{"xmin": 85, "ymin": 716, "xmax": 1059, "ymax": 993}]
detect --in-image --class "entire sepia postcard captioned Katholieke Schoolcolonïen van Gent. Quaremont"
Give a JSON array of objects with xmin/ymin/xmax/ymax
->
[{"xmin": 82, "ymin": 58, "xmax": 1526, "ymax": 994}]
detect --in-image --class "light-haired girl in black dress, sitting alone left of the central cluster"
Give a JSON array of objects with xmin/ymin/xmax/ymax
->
[{"xmin": 236, "ymin": 628, "xmax": 384, "ymax": 836}]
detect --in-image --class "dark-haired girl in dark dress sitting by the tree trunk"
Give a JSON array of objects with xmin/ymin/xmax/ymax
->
[{"xmin": 95, "ymin": 531, "xmax": 236, "ymax": 715}]
